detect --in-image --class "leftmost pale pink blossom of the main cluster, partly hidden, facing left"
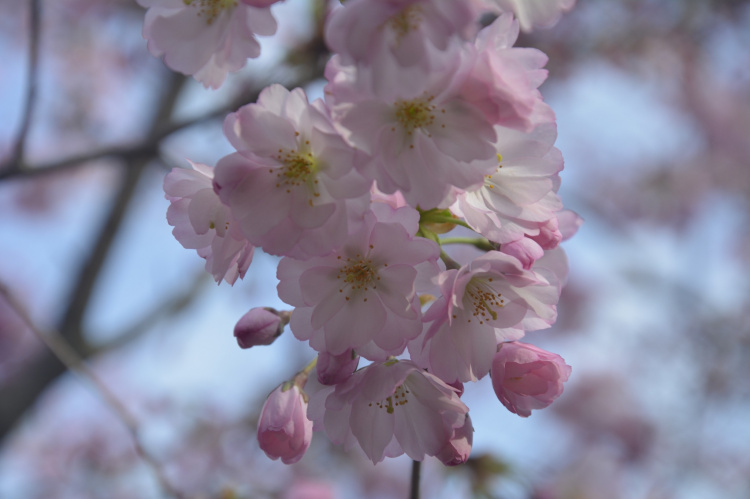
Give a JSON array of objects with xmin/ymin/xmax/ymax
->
[{"xmin": 164, "ymin": 162, "xmax": 254, "ymax": 284}]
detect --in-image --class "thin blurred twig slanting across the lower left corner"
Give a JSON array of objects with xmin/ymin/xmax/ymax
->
[{"xmin": 0, "ymin": 282, "xmax": 182, "ymax": 498}]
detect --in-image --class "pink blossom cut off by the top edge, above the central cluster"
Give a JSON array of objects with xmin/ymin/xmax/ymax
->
[{"xmin": 326, "ymin": 0, "xmax": 479, "ymax": 70}]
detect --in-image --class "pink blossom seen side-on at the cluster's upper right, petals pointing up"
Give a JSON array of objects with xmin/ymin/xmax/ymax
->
[{"xmin": 463, "ymin": 14, "xmax": 554, "ymax": 131}]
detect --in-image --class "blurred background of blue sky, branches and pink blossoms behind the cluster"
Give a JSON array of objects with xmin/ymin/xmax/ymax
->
[{"xmin": 0, "ymin": 0, "xmax": 750, "ymax": 499}]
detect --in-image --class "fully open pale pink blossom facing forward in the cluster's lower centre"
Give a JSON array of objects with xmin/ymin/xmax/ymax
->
[{"xmin": 277, "ymin": 209, "xmax": 440, "ymax": 360}]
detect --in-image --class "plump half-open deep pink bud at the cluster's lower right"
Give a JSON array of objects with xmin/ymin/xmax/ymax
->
[{"xmin": 490, "ymin": 341, "xmax": 571, "ymax": 417}]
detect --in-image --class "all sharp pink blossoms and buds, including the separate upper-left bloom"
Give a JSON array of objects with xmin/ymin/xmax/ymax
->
[{"xmin": 150, "ymin": 0, "xmax": 581, "ymax": 465}]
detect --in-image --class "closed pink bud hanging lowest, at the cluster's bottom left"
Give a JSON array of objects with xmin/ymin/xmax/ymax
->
[{"xmin": 258, "ymin": 383, "xmax": 313, "ymax": 464}]
